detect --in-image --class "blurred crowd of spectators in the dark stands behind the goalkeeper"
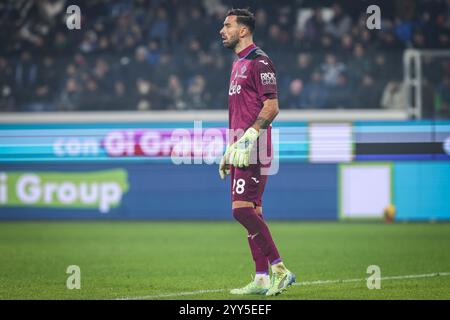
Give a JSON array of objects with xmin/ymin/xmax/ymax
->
[{"xmin": 0, "ymin": 0, "xmax": 450, "ymax": 116}]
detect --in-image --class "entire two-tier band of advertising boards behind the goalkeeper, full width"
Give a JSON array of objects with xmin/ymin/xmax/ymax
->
[{"xmin": 0, "ymin": 121, "xmax": 450, "ymax": 220}]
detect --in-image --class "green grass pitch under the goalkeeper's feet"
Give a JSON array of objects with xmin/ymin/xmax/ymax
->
[{"xmin": 0, "ymin": 221, "xmax": 450, "ymax": 300}]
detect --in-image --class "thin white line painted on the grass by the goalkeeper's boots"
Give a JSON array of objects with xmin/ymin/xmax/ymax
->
[{"xmin": 116, "ymin": 272, "xmax": 450, "ymax": 300}]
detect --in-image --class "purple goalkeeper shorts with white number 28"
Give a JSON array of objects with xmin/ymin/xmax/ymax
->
[{"xmin": 230, "ymin": 164, "xmax": 267, "ymax": 207}]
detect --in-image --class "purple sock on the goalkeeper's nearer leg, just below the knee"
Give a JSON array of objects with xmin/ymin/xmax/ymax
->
[{"xmin": 233, "ymin": 207, "xmax": 280, "ymax": 263}]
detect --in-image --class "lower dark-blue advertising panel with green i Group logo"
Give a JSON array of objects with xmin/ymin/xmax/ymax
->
[{"xmin": 0, "ymin": 163, "xmax": 337, "ymax": 220}]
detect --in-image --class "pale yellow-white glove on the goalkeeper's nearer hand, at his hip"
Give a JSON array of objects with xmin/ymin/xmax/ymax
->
[{"xmin": 229, "ymin": 127, "xmax": 259, "ymax": 168}]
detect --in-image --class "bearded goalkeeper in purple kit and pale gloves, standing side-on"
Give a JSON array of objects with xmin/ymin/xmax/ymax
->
[{"xmin": 219, "ymin": 9, "xmax": 295, "ymax": 296}]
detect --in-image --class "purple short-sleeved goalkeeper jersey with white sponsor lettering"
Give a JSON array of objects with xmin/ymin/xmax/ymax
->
[{"xmin": 228, "ymin": 44, "xmax": 277, "ymax": 133}]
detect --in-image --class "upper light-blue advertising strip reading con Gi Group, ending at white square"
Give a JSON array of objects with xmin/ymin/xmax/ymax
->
[{"xmin": 0, "ymin": 121, "xmax": 308, "ymax": 164}]
